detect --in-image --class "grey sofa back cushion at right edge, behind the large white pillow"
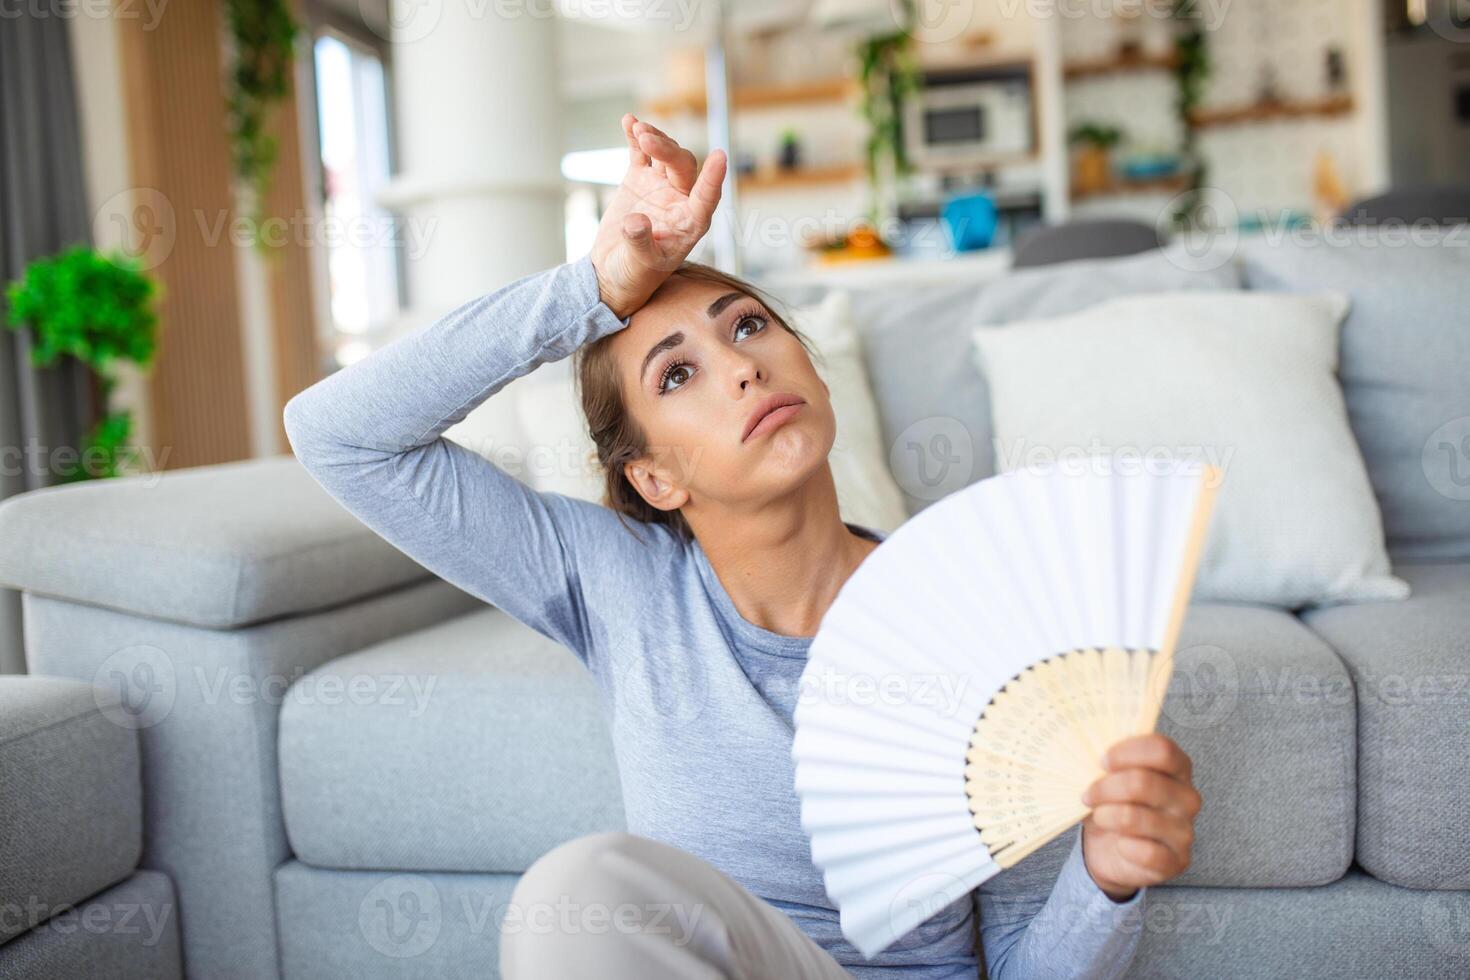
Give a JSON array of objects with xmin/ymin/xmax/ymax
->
[{"xmin": 1241, "ymin": 225, "xmax": 1470, "ymax": 560}]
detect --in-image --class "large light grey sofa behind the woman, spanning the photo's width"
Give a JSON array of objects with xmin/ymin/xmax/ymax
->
[{"xmin": 0, "ymin": 233, "xmax": 1470, "ymax": 980}]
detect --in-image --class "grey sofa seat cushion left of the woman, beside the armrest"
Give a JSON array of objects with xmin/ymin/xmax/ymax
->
[{"xmin": 279, "ymin": 608, "xmax": 625, "ymax": 873}]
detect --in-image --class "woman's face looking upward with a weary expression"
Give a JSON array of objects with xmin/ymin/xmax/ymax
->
[{"xmin": 612, "ymin": 276, "xmax": 836, "ymax": 511}]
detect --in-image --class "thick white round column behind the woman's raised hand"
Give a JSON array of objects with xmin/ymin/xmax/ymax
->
[{"xmin": 379, "ymin": 0, "xmax": 566, "ymax": 318}]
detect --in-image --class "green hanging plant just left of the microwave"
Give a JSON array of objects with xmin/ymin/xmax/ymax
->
[{"xmin": 857, "ymin": 0, "xmax": 919, "ymax": 226}]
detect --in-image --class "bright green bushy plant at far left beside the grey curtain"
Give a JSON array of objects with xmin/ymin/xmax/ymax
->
[{"xmin": 6, "ymin": 245, "xmax": 159, "ymax": 483}]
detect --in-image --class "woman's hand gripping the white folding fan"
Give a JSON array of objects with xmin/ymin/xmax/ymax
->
[{"xmin": 1082, "ymin": 733, "xmax": 1204, "ymax": 902}]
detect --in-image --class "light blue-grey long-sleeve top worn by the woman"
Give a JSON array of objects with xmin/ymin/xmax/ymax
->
[{"xmin": 285, "ymin": 259, "xmax": 1145, "ymax": 980}]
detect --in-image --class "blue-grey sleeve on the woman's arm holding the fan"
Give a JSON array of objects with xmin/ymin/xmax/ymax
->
[{"xmin": 975, "ymin": 826, "xmax": 1147, "ymax": 980}]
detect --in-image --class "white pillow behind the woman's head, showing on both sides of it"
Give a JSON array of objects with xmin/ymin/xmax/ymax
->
[{"xmin": 516, "ymin": 292, "xmax": 907, "ymax": 532}]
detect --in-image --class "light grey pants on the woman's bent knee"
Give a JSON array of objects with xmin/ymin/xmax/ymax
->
[{"xmin": 500, "ymin": 832, "xmax": 851, "ymax": 980}]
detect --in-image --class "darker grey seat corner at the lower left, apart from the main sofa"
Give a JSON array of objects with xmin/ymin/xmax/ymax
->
[{"xmin": 0, "ymin": 676, "xmax": 184, "ymax": 980}]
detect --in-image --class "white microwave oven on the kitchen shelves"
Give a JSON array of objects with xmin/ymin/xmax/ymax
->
[{"xmin": 904, "ymin": 69, "xmax": 1033, "ymax": 167}]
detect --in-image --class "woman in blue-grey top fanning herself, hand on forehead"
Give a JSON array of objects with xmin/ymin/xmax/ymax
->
[{"xmin": 285, "ymin": 115, "xmax": 1200, "ymax": 980}]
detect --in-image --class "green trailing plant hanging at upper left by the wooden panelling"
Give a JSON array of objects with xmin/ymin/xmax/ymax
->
[{"xmin": 225, "ymin": 0, "xmax": 298, "ymax": 251}]
